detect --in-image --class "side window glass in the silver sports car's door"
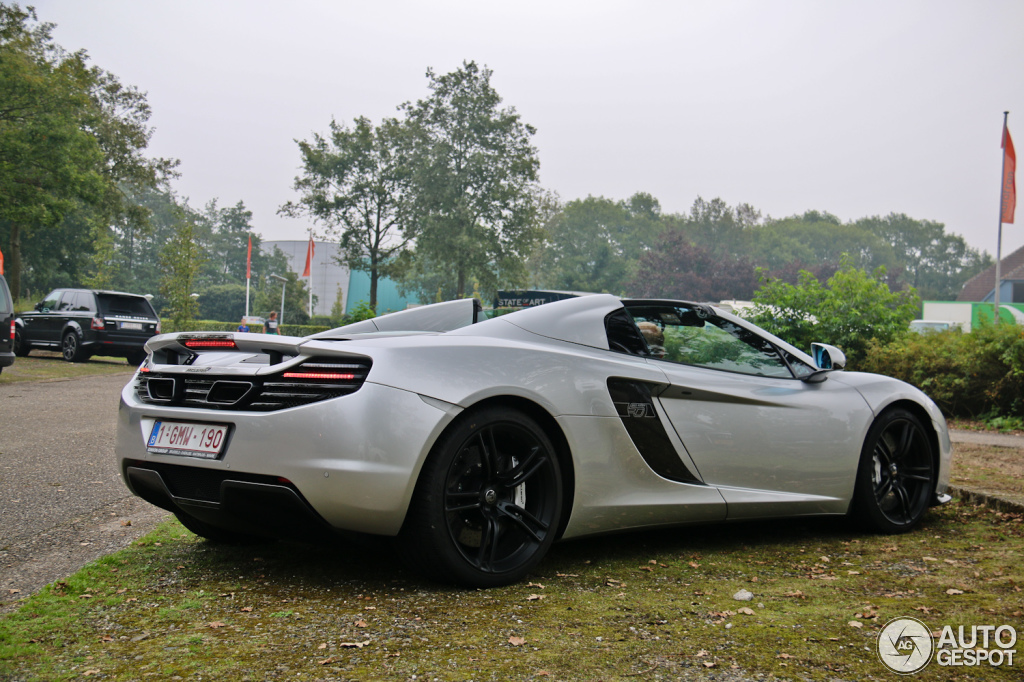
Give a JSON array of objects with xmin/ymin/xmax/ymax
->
[{"xmin": 629, "ymin": 304, "xmax": 793, "ymax": 379}]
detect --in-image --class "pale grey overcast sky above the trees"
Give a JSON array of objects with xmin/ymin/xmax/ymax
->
[{"xmin": 32, "ymin": 0, "xmax": 1024, "ymax": 255}]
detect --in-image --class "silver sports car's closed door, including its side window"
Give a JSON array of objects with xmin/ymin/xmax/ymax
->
[{"xmin": 630, "ymin": 304, "xmax": 870, "ymax": 518}]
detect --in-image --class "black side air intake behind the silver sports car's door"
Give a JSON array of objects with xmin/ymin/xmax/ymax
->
[{"xmin": 608, "ymin": 377, "xmax": 702, "ymax": 484}]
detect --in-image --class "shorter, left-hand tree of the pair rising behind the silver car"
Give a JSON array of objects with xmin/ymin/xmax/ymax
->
[{"xmin": 281, "ymin": 117, "xmax": 414, "ymax": 310}]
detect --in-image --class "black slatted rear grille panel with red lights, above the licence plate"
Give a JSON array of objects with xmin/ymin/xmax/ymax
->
[{"xmin": 135, "ymin": 357, "xmax": 372, "ymax": 412}]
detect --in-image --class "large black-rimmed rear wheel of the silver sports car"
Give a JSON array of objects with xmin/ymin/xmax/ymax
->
[{"xmin": 399, "ymin": 407, "xmax": 563, "ymax": 588}]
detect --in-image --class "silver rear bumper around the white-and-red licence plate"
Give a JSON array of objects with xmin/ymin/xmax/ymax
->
[{"xmin": 115, "ymin": 379, "xmax": 458, "ymax": 536}]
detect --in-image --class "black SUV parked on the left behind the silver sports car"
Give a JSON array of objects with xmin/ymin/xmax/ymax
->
[{"xmin": 14, "ymin": 289, "xmax": 160, "ymax": 365}]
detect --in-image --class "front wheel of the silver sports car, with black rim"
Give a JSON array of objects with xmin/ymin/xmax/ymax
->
[{"xmin": 853, "ymin": 409, "xmax": 936, "ymax": 534}]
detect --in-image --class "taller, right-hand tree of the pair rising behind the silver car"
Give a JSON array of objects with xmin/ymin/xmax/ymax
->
[{"xmin": 402, "ymin": 61, "xmax": 541, "ymax": 297}]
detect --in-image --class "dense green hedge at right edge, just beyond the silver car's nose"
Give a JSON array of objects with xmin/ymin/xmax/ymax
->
[{"xmin": 857, "ymin": 324, "xmax": 1024, "ymax": 419}]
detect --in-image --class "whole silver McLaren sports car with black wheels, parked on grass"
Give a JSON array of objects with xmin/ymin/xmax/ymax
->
[{"xmin": 117, "ymin": 295, "xmax": 950, "ymax": 587}]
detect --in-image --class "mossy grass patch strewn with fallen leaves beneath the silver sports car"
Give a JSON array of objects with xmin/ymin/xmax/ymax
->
[{"xmin": 0, "ymin": 501, "xmax": 1024, "ymax": 680}]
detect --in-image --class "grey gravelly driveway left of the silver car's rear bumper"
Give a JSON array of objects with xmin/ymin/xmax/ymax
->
[{"xmin": 0, "ymin": 373, "xmax": 167, "ymax": 611}]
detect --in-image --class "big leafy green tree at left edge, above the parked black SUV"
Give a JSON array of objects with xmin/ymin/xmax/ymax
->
[{"xmin": 0, "ymin": 5, "xmax": 176, "ymax": 295}]
